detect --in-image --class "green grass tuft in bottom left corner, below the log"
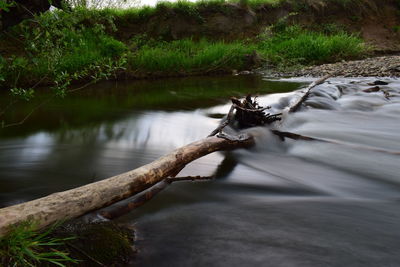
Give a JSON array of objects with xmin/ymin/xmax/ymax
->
[{"xmin": 0, "ymin": 222, "xmax": 77, "ymax": 267}]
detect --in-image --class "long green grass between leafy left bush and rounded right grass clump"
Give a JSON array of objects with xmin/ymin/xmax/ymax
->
[{"xmin": 128, "ymin": 39, "xmax": 252, "ymax": 73}]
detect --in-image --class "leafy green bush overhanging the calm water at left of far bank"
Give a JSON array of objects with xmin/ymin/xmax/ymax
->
[{"xmin": 0, "ymin": 9, "xmax": 127, "ymax": 100}]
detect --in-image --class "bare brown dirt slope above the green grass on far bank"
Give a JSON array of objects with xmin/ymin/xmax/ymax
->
[{"xmin": 112, "ymin": 0, "xmax": 400, "ymax": 53}]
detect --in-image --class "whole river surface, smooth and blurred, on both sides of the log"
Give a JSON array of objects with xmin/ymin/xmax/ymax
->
[{"xmin": 0, "ymin": 76, "xmax": 400, "ymax": 266}]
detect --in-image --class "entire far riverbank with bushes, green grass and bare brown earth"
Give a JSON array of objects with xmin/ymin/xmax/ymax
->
[{"xmin": 0, "ymin": 0, "xmax": 400, "ymax": 100}]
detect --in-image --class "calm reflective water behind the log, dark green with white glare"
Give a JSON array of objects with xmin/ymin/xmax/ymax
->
[{"xmin": 0, "ymin": 76, "xmax": 297, "ymax": 206}]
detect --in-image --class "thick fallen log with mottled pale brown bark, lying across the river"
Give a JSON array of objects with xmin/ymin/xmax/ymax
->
[{"xmin": 0, "ymin": 136, "xmax": 254, "ymax": 236}]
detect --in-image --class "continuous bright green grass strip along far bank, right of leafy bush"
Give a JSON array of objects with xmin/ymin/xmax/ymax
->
[{"xmin": 128, "ymin": 26, "xmax": 367, "ymax": 74}]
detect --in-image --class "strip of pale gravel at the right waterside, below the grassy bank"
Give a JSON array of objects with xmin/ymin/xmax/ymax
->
[{"xmin": 268, "ymin": 55, "xmax": 400, "ymax": 77}]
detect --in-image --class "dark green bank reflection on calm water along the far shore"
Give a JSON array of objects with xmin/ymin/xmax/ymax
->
[{"xmin": 0, "ymin": 76, "xmax": 297, "ymax": 137}]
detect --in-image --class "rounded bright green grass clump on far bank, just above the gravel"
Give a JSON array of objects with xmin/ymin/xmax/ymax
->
[{"xmin": 258, "ymin": 26, "xmax": 367, "ymax": 64}]
